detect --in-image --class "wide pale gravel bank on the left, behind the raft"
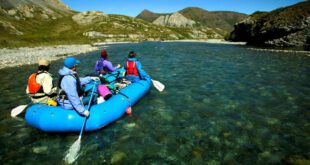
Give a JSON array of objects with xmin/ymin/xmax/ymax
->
[{"xmin": 0, "ymin": 45, "xmax": 98, "ymax": 69}]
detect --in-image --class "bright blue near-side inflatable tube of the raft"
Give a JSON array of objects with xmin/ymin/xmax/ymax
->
[{"xmin": 25, "ymin": 79, "xmax": 151, "ymax": 132}]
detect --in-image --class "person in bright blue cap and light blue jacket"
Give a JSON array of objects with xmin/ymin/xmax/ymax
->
[{"xmin": 57, "ymin": 57, "xmax": 99, "ymax": 117}]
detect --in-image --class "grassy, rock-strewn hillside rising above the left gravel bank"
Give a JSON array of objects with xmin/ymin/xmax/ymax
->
[{"xmin": 0, "ymin": 0, "xmax": 188, "ymax": 47}]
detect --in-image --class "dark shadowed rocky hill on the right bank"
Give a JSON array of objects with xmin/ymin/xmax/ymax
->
[{"xmin": 229, "ymin": 1, "xmax": 310, "ymax": 49}]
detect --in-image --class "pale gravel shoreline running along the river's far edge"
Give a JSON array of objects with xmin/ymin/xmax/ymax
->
[{"xmin": 0, "ymin": 39, "xmax": 310, "ymax": 70}]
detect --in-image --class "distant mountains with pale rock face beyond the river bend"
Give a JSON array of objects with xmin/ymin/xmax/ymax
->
[{"xmin": 136, "ymin": 7, "xmax": 247, "ymax": 39}]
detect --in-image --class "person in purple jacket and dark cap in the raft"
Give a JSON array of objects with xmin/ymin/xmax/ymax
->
[{"xmin": 95, "ymin": 49, "xmax": 121, "ymax": 75}]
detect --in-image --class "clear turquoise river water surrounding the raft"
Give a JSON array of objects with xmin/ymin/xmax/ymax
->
[{"xmin": 0, "ymin": 43, "xmax": 310, "ymax": 164}]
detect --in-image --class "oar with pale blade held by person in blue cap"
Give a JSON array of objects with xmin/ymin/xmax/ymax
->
[{"xmin": 65, "ymin": 82, "xmax": 96, "ymax": 164}]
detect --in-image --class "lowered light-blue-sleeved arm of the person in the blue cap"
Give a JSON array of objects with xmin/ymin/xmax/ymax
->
[{"xmin": 61, "ymin": 76, "xmax": 85, "ymax": 114}]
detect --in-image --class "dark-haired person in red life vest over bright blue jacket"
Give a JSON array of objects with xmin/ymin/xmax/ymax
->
[{"xmin": 124, "ymin": 51, "xmax": 149, "ymax": 83}]
